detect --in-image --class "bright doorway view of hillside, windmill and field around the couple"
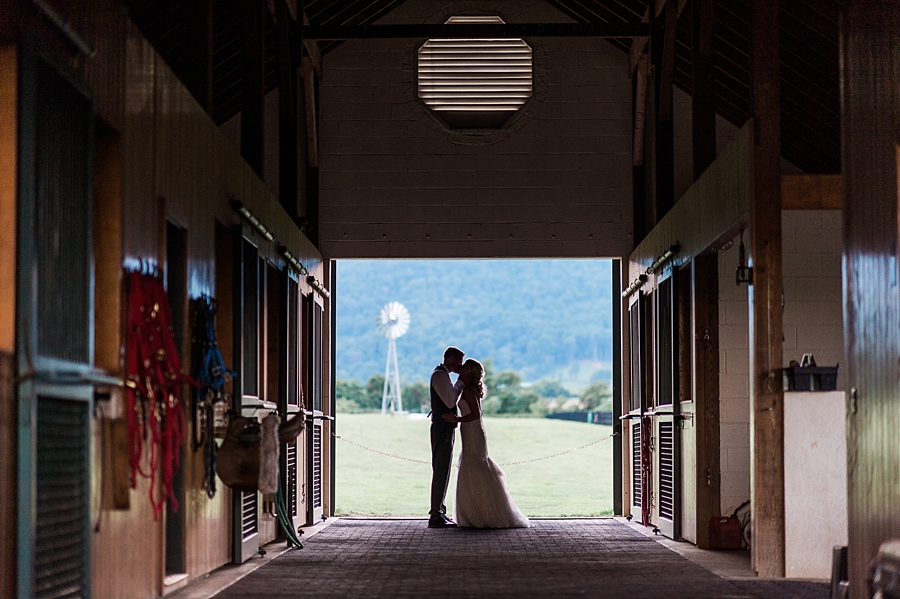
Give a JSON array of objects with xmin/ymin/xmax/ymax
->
[{"xmin": 335, "ymin": 259, "xmax": 620, "ymax": 517}]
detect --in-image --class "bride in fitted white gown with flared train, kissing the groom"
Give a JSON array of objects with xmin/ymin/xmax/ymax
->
[{"xmin": 444, "ymin": 359, "xmax": 530, "ymax": 528}]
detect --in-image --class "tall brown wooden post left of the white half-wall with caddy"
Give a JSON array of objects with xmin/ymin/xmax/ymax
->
[{"xmin": 749, "ymin": 0, "xmax": 784, "ymax": 578}]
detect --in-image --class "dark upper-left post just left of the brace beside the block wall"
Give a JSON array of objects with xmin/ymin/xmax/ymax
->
[{"xmin": 275, "ymin": 0, "xmax": 297, "ymax": 219}]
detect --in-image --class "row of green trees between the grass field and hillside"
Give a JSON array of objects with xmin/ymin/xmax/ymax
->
[{"xmin": 335, "ymin": 358, "xmax": 612, "ymax": 417}]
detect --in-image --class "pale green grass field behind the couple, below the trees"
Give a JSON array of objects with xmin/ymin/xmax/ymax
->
[{"xmin": 336, "ymin": 414, "xmax": 612, "ymax": 516}]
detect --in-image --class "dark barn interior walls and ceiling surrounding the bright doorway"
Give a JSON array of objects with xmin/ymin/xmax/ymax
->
[{"xmin": 0, "ymin": 0, "xmax": 900, "ymax": 599}]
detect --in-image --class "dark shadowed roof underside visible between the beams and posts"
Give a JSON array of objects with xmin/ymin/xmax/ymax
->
[{"xmin": 128, "ymin": 0, "xmax": 842, "ymax": 173}]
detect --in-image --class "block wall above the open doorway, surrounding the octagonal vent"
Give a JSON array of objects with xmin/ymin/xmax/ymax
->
[{"xmin": 320, "ymin": 0, "xmax": 633, "ymax": 258}]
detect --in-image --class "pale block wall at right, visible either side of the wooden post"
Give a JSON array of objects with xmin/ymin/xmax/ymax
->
[{"xmin": 719, "ymin": 210, "xmax": 844, "ymax": 514}]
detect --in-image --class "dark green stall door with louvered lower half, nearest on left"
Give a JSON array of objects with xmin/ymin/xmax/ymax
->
[{"xmin": 16, "ymin": 51, "xmax": 96, "ymax": 599}]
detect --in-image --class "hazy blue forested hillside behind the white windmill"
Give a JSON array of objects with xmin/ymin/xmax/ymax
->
[{"xmin": 337, "ymin": 260, "xmax": 612, "ymax": 386}]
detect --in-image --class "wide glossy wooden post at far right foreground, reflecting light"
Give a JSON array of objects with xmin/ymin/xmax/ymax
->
[{"xmin": 840, "ymin": 0, "xmax": 900, "ymax": 599}]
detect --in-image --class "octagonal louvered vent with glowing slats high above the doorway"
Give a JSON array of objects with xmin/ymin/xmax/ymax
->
[{"xmin": 418, "ymin": 16, "xmax": 532, "ymax": 129}]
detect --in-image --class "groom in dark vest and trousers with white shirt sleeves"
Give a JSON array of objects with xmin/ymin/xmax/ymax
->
[{"xmin": 428, "ymin": 347, "xmax": 466, "ymax": 528}]
